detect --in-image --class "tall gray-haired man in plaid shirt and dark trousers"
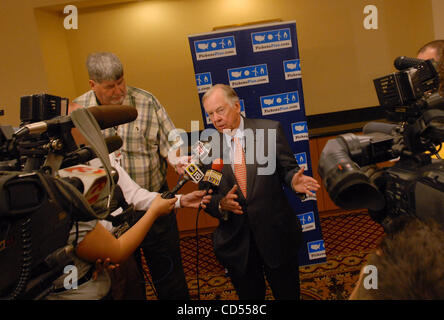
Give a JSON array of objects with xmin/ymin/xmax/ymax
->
[{"xmin": 73, "ymin": 52, "xmax": 189, "ymax": 299}]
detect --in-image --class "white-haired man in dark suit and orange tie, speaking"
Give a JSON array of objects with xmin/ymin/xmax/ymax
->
[{"xmin": 202, "ymin": 84, "xmax": 319, "ymax": 300}]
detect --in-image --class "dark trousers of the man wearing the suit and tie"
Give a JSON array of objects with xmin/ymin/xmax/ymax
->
[{"xmin": 228, "ymin": 236, "xmax": 300, "ymax": 300}]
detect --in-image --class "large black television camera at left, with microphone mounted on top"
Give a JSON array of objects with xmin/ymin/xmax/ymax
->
[{"xmin": 0, "ymin": 94, "xmax": 137, "ymax": 299}]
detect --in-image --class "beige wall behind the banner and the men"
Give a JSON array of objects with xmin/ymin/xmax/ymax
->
[{"xmin": 0, "ymin": 0, "xmax": 439, "ymax": 131}]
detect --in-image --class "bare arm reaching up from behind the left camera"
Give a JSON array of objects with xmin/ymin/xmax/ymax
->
[{"xmin": 76, "ymin": 196, "xmax": 177, "ymax": 263}]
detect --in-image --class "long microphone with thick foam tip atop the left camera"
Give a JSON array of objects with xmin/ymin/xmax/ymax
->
[{"xmin": 15, "ymin": 105, "xmax": 137, "ymax": 137}]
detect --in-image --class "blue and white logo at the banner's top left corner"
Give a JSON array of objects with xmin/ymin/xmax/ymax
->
[{"xmin": 194, "ymin": 36, "xmax": 237, "ymax": 60}]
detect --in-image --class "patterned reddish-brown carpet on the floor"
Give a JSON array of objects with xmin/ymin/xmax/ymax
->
[{"xmin": 144, "ymin": 212, "xmax": 384, "ymax": 300}]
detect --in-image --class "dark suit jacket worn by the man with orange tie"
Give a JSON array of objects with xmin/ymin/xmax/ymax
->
[{"xmin": 205, "ymin": 118, "xmax": 302, "ymax": 274}]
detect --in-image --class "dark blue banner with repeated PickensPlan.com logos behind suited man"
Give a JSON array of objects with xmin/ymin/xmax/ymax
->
[{"xmin": 189, "ymin": 22, "xmax": 326, "ymax": 265}]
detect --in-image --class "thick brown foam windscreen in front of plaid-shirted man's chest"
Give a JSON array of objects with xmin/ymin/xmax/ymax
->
[{"xmin": 88, "ymin": 105, "xmax": 137, "ymax": 129}]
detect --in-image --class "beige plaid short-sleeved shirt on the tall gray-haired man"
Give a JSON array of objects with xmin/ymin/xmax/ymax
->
[{"xmin": 73, "ymin": 86, "xmax": 180, "ymax": 192}]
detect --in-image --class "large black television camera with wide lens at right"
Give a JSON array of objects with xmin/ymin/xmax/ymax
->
[{"xmin": 318, "ymin": 57, "xmax": 444, "ymax": 233}]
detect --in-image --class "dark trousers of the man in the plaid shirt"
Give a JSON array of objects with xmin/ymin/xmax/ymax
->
[{"xmin": 135, "ymin": 212, "xmax": 190, "ymax": 300}]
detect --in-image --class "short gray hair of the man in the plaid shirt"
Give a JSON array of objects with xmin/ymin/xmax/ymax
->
[{"xmin": 86, "ymin": 52, "xmax": 123, "ymax": 83}]
